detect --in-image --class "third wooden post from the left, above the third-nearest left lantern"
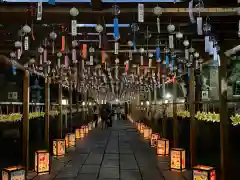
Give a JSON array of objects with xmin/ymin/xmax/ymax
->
[{"xmin": 58, "ymin": 83, "xmax": 63, "ymax": 138}]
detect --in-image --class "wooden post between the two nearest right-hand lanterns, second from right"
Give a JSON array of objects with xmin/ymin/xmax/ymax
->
[{"xmin": 188, "ymin": 67, "xmax": 196, "ymax": 167}]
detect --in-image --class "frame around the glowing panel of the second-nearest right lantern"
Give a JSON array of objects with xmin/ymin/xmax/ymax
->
[{"xmin": 170, "ymin": 148, "xmax": 186, "ymax": 172}]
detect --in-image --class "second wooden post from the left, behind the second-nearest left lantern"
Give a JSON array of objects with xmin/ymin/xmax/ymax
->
[{"xmin": 44, "ymin": 77, "xmax": 50, "ymax": 150}]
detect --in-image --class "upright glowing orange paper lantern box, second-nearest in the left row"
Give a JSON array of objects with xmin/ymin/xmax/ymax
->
[{"xmin": 35, "ymin": 150, "xmax": 50, "ymax": 175}]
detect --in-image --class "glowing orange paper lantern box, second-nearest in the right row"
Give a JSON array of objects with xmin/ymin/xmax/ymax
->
[{"xmin": 170, "ymin": 148, "xmax": 186, "ymax": 172}]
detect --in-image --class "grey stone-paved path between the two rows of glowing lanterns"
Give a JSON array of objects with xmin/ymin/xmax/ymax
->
[{"xmin": 28, "ymin": 120, "xmax": 191, "ymax": 180}]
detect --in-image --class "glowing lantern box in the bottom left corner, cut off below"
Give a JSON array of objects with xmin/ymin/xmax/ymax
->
[{"xmin": 2, "ymin": 166, "xmax": 26, "ymax": 180}]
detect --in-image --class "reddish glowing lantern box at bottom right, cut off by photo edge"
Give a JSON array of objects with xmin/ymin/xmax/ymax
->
[{"xmin": 193, "ymin": 165, "xmax": 216, "ymax": 180}]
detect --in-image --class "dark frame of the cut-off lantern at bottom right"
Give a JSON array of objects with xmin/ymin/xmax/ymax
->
[{"xmin": 192, "ymin": 165, "xmax": 216, "ymax": 180}]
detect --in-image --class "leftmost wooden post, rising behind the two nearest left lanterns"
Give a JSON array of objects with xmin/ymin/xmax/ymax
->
[{"xmin": 23, "ymin": 70, "xmax": 29, "ymax": 171}]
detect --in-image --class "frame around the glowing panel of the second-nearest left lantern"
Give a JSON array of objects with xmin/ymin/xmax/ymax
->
[{"xmin": 35, "ymin": 150, "xmax": 51, "ymax": 175}]
